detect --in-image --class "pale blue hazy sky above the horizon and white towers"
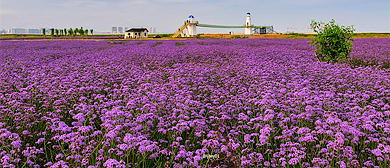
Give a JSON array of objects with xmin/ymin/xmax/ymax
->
[{"xmin": 0, "ymin": 0, "xmax": 390, "ymax": 33}]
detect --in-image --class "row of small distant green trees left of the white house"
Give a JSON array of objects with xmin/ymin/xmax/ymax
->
[{"xmin": 42, "ymin": 27, "xmax": 93, "ymax": 37}]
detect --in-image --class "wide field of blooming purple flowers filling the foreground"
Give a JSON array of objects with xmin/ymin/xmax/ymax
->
[{"xmin": 0, "ymin": 38, "xmax": 390, "ymax": 168}]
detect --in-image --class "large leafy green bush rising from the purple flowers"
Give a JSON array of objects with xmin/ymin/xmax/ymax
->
[{"xmin": 310, "ymin": 19, "xmax": 355, "ymax": 63}]
